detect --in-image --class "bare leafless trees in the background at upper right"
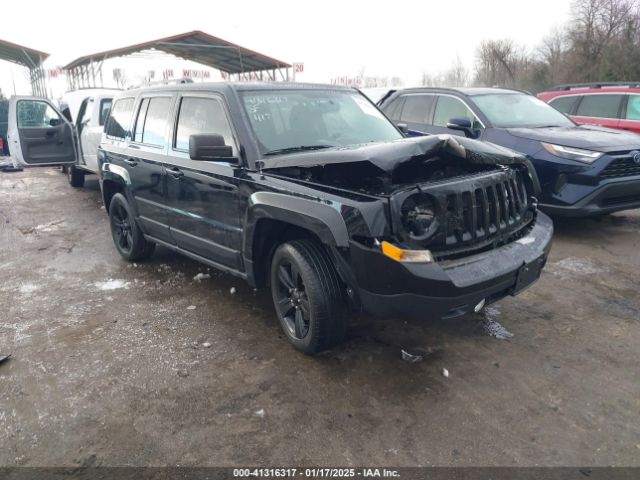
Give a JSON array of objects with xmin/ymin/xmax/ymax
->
[{"xmin": 422, "ymin": 0, "xmax": 640, "ymax": 92}]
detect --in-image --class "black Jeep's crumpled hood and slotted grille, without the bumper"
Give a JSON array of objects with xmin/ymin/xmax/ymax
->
[{"xmin": 269, "ymin": 135, "xmax": 540, "ymax": 259}]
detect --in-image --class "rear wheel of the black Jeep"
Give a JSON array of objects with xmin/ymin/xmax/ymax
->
[{"xmin": 109, "ymin": 193, "xmax": 156, "ymax": 262}]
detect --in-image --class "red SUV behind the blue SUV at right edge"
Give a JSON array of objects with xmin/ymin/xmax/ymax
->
[{"xmin": 538, "ymin": 82, "xmax": 640, "ymax": 134}]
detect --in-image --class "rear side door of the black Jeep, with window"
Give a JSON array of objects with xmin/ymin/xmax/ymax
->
[{"xmin": 120, "ymin": 92, "xmax": 175, "ymax": 243}]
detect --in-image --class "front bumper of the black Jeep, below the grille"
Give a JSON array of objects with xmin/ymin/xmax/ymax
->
[{"xmin": 351, "ymin": 213, "xmax": 553, "ymax": 318}]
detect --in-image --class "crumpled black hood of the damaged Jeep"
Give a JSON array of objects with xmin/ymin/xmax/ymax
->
[{"xmin": 264, "ymin": 135, "xmax": 529, "ymax": 173}]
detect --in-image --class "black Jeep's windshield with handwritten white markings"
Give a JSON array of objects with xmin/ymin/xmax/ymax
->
[{"xmin": 241, "ymin": 89, "xmax": 402, "ymax": 155}]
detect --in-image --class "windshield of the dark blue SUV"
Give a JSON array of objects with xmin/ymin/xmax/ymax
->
[{"xmin": 473, "ymin": 93, "xmax": 574, "ymax": 128}]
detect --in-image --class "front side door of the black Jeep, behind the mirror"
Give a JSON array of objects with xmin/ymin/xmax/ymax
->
[{"xmin": 166, "ymin": 92, "xmax": 242, "ymax": 271}]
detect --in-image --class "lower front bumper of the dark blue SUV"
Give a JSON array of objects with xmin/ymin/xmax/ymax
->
[{"xmin": 540, "ymin": 177, "xmax": 640, "ymax": 217}]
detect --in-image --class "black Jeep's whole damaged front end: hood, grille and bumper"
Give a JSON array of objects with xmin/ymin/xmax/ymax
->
[{"xmin": 267, "ymin": 135, "xmax": 553, "ymax": 318}]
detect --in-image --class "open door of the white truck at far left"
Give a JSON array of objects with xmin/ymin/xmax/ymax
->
[{"xmin": 7, "ymin": 96, "xmax": 77, "ymax": 166}]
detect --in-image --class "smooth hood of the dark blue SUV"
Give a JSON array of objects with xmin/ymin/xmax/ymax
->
[{"xmin": 507, "ymin": 125, "xmax": 640, "ymax": 152}]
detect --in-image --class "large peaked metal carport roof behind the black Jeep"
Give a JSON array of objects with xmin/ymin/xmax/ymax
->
[{"xmin": 64, "ymin": 30, "xmax": 291, "ymax": 74}]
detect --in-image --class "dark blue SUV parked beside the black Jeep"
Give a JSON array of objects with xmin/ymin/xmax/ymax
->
[{"xmin": 378, "ymin": 88, "xmax": 640, "ymax": 216}]
